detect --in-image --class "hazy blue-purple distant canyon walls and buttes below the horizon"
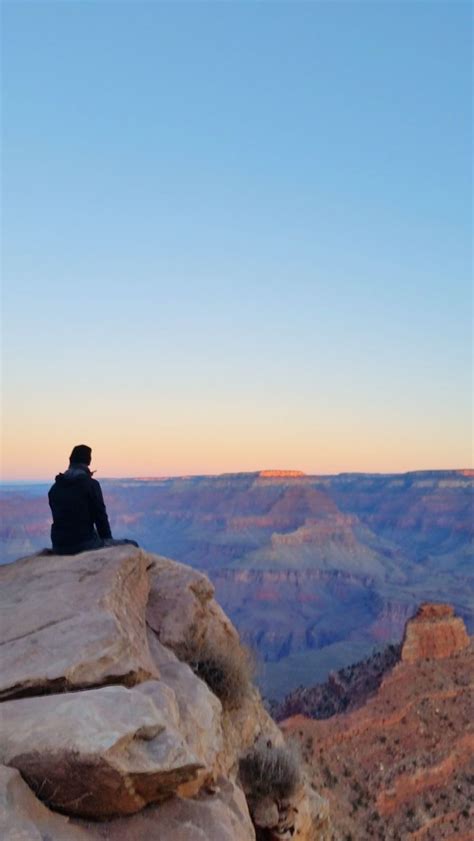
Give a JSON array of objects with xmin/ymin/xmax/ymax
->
[{"xmin": 0, "ymin": 470, "xmax": 474, "ymax": 700}]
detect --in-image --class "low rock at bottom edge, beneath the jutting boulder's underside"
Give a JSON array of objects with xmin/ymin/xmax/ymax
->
[{"xmin": 73, "ymin": 779, "xmax": 255, "ymax": 841}]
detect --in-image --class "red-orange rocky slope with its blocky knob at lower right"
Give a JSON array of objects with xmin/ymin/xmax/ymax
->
[{"xmin": 281, "ymin": 604, "xmax": 474, "ymax": 841}]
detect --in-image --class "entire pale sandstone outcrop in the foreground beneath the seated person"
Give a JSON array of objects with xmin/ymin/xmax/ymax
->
[{"xmin": 0, "ymin": 547, "xmax": 331, "ymax": 841}]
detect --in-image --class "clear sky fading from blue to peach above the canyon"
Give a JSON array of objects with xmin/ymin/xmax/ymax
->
[{"xmin": 1, "ymin": 0, "xmax": 473, "ymax": 481}]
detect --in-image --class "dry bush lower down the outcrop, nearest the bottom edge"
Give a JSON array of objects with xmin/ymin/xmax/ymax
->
[{"xmin": 239, "ymin": 746, "xmax": 301, "ymax": 801}]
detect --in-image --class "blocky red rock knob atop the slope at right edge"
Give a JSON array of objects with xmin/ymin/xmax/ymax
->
[{"xmin": 401, "ymin": 603, "xmax": 469, "ymax": 663}]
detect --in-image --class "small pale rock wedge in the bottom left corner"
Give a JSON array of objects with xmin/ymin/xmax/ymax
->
[{"xmin": 0, "ymin": 767, "xmax": 90, "ymax": 841}]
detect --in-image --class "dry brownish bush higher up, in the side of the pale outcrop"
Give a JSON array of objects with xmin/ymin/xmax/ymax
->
[{"xmin": 177, "ymin": 640, "xmax": 253, "ymax": 709}]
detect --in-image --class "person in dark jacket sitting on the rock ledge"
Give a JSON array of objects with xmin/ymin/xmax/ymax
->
[{"xmin": 48, "ymin": 444, "xmax": 138, "ymax": 555}]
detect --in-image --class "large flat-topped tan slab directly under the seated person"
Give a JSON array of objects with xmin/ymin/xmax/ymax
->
[{"xmin": 0, "ymin": 546, "xmax": 156, "ymax": 698}]
